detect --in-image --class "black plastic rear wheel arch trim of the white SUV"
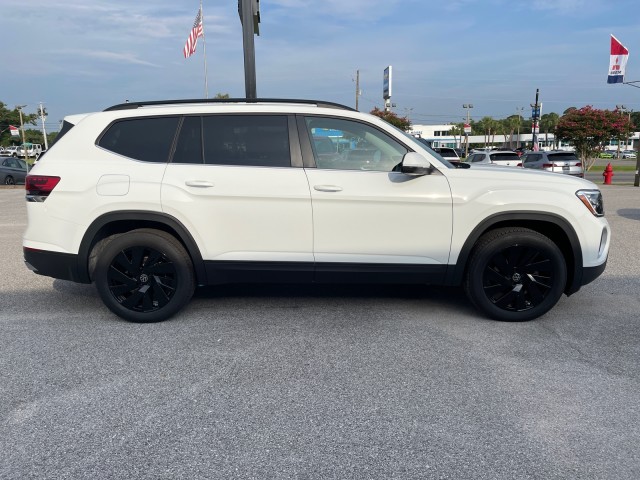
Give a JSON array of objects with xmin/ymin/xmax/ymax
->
[{"xmin": 78, "ymin": 210, "xmax": 207, "ymax": 285}]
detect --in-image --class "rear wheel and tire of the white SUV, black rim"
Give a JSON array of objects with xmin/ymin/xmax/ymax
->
[{"xmin": 93, "ymin": 229, "xmax": 195, "ymax": 323}]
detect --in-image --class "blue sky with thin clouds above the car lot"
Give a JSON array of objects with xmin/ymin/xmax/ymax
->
[{"xmin": 0, "ymin": 0, "xmax": 640, "ymax": 132}]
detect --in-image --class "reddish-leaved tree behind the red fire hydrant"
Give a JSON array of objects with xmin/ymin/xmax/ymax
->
[{"xmin": 556, "ymin": 105, "xmax": 631, "ymax": 170}]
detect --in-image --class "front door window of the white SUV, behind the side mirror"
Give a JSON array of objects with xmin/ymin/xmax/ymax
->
[{"xmin": 306, "ymin": 117, "xmax": 407, "ymax": 172}]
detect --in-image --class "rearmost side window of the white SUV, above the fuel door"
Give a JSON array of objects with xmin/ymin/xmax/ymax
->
[{"xmin": 98, "ymin": 117, "xmax": 179, "ymax": 163}]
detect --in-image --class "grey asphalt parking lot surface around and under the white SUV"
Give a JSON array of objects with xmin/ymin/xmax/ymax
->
[{"xmin": 0, "ymin": 185, "xmax": 640, "ymax": 480}]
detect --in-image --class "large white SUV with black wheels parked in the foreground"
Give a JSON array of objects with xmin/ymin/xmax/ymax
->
[{"xmin": 23, "ymin": 99, "xmax": 610, "ymax": 322}]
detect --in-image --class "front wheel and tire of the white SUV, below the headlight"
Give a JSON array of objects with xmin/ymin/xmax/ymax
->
[{"xmin": 464, "ymin": 227, "xmax": 567, "ymax": 322}]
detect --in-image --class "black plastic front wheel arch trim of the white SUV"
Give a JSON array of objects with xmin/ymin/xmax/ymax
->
[{"xmin": 445, "ymin": 212, "xmax": 582, "ymax": 295}]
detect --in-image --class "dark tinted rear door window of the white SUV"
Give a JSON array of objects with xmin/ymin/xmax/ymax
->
[{"xmin": 202, "ymin": 115, "xmax": 291, "ymax": 167}]
